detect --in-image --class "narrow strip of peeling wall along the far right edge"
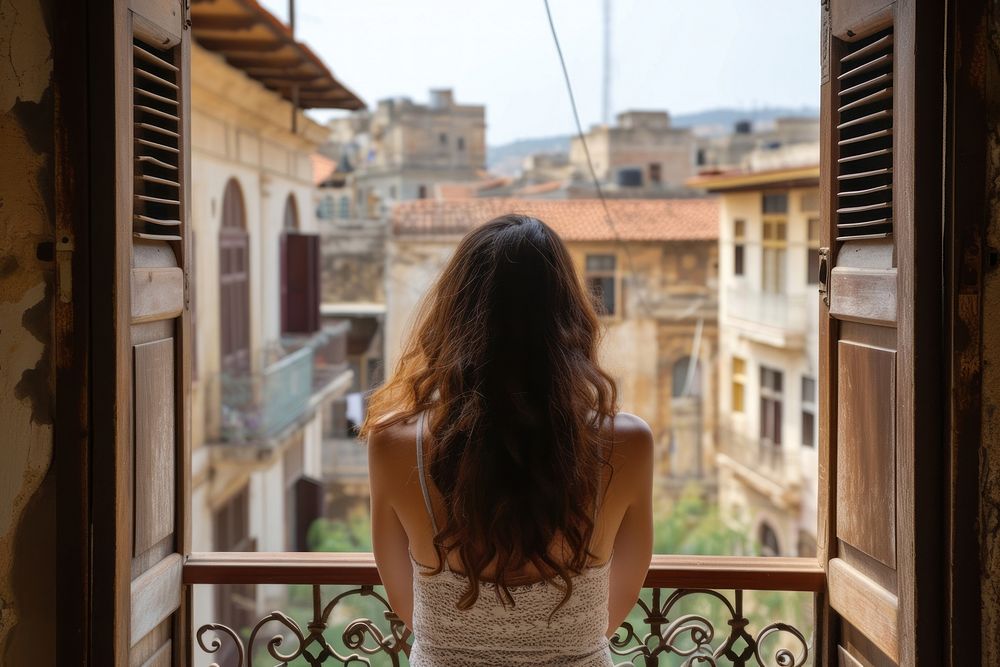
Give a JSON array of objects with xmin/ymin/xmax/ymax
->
[{"xmin": 979, "ymin": 2, "xmax": 1000, "ymax": 667}]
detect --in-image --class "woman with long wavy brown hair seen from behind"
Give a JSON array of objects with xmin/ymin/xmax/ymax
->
[{"xmin": 362, "ymin": 215, "xmax": 652, "ymax": 667}]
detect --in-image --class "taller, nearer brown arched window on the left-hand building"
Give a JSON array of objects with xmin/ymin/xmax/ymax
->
[{"xmin": 219, "ymin": 178, "xmax": 250, "ymax": 368}]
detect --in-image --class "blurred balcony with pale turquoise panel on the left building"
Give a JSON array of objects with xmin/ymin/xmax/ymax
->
[{"xmin": 210, "ymin": 323, "xmax": 352, "ymax": 447}]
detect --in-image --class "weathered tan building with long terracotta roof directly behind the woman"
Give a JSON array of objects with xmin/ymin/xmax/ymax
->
[{"xmin": 385, "ymin": 199, "xmax": 718, "ymax": 490}]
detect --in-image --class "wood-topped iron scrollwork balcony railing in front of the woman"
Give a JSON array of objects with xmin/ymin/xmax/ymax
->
[{"xmin": 183, "ymin": 553, "xmax": 825, "ymax": 667}]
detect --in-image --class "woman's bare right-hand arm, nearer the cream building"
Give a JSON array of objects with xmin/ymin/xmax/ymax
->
[{"xmin": 607, "ymin": 419, "xmax": 653, "ymax": 637}]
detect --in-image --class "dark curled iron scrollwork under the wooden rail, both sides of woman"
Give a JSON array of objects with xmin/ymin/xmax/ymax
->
[{"xmin": 196, "ymin": 585, "xmax": 809, "ymax": 667}]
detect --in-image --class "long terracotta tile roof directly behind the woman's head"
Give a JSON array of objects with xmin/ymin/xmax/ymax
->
[{"xmin": 392, "ymin": 198, "xmax": 719, "ymax": 241}]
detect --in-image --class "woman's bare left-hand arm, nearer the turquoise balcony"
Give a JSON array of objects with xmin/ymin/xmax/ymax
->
[{"xmin": 368, "ymin": 433, "xmax": 413, "ymax": 628}]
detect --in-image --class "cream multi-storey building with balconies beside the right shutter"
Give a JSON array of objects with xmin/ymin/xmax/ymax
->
[{"xmin": 692, "ymin": 158, "xmax": 820, "ymax": 556}]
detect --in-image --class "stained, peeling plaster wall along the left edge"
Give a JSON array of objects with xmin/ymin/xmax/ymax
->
[{"xmin": 0, "ymin": 0, "xmax": 56, "ymax": 665}]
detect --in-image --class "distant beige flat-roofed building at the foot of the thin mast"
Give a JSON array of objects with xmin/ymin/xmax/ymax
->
[{"xmin": 569, "ymin": 111, "xmax": 695, "ymax": 197}]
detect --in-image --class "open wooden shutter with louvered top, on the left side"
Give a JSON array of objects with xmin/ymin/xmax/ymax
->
[{"xmin": 88, "ymin": 0, "xmax": 191, "ymax": 665}]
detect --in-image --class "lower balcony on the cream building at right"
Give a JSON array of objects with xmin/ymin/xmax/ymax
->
[{"xmin": 718, "ymin": 425, "xmax": 802, "ymax": 507}]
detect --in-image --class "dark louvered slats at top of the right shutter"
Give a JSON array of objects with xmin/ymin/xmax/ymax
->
[{"xmin": 836, "ymin": 29, "xmax": 893, "ymax": 241}]
